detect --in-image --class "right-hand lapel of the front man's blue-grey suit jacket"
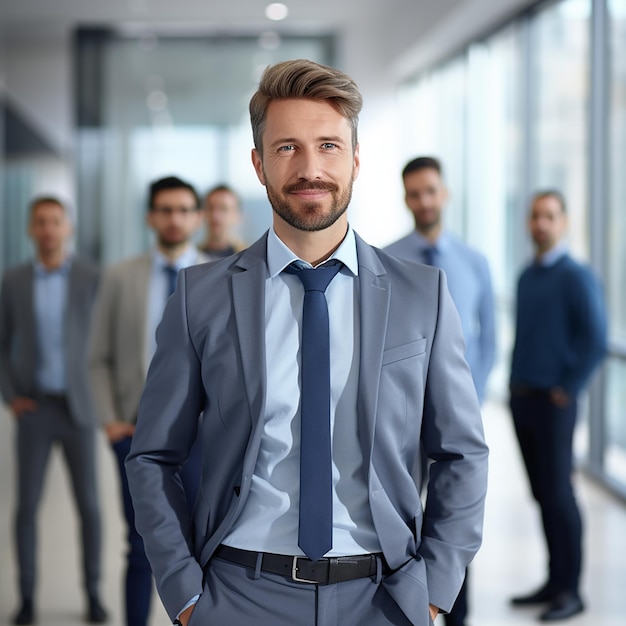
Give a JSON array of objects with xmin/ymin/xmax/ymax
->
[{"xmin": 356, "ymin": 236, "xmax": 391, "ymax": 460}]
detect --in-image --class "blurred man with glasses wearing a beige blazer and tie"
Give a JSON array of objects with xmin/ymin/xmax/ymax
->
[{"xmin": 89, "ymin": 176, "xmax": 206, "ymax": 626}]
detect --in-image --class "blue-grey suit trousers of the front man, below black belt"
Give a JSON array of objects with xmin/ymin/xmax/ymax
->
[{"xmin": 189, "ymin": 559, "xmax": 416, "ymax": 626}]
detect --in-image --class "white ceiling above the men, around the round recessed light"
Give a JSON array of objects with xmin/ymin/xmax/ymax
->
[{"xmin": 0, "ymin": 0, "xmax": 535, "ymax": 75}]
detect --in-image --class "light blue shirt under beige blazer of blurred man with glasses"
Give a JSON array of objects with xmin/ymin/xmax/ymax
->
[{"xmin": 145, "ymin": 245, "xmax": 204, "ymax": 372}]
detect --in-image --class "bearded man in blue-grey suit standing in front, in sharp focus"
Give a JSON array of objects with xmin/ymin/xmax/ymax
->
[{"xmin": 127, "ymin": 60, "xmax": 487, "ymax": 626}]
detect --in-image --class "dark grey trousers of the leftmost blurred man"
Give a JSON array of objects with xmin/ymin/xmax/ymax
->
[{"xmin": 15, "ymin": 401, "xmax": 101, "ymax": 599}]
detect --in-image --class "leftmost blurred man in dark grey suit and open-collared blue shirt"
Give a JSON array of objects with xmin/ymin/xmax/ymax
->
[{"xmin": 0, "ymin": 197, "xmax": 107, "ymax": 624}]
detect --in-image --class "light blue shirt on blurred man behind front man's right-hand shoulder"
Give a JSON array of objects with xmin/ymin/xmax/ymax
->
[{"xmin": 385, "ymin": 230, "xmax": 496, "ymax": 402}]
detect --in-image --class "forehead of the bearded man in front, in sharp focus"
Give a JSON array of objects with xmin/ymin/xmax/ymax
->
[{"xmin": 264, "ymin": 98, "xmax": 352, "ymax": 143}]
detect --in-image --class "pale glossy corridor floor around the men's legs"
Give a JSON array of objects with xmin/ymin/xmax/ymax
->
[{"xmin": 0, "ymin": 403, "xmax": 626, "ymax": 626}]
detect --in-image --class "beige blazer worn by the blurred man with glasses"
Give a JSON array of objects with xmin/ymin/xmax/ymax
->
[{"xmin": 89, "ymin": 252, "xmax": 206, "ymax": 424}]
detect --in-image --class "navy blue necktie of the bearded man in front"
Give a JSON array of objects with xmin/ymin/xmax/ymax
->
[{"xmin": 285, "ymin": 261, "xmax": 342, "ymax": 561}]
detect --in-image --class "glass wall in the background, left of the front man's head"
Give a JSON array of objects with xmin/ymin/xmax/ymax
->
[{"xmin": 76, "ymin": 30, "xmax": 332, "ymax": 263}]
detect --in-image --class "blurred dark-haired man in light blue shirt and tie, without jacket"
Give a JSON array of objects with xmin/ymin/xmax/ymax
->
[{"xmin": 386, "ymin": 157, "xmax": 496, "ymax": 626}]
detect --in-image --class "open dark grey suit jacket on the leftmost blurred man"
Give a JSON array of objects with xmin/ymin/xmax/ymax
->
[{"xmin": 0, "ymin": 258, "xmax": 99, "ymax": 426}]
